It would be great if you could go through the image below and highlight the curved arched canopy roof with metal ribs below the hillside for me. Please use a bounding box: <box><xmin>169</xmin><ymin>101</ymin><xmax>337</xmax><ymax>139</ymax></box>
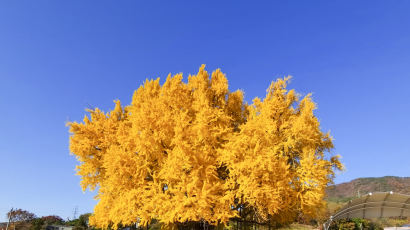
<box><xmin>325</xmin><ymin>192</ymin><xmax>410</xmax><ymax>229</ymax></box>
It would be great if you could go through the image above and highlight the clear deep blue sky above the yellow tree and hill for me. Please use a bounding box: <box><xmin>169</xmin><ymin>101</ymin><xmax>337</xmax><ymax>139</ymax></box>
<box><xmin>0</xmin><ymin>0</ymin><xmax>410</xmax><ymax>221</ymax></box>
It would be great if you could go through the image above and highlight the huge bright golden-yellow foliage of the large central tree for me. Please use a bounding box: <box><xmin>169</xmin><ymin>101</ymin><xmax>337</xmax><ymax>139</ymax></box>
<box><xmin>69</xmin><ymin>66</ymin><xmax>342</xmax><ymax>228</ymax></box>
